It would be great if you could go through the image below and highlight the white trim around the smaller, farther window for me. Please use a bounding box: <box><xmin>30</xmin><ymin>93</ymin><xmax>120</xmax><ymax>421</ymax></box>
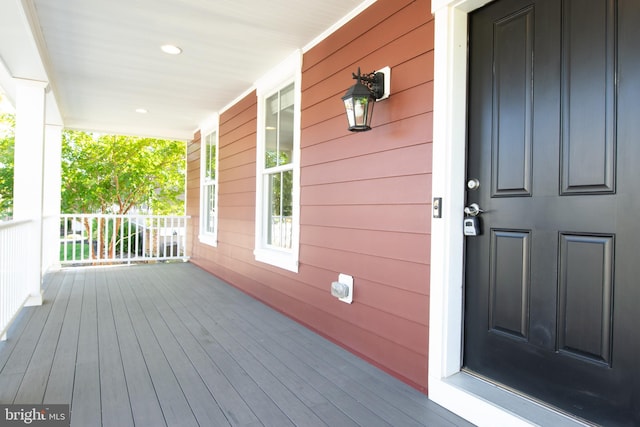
<box><xmin>198</xmin><ymin>114</ymin><xmax>220</xmax><ymax>246</ymax></box>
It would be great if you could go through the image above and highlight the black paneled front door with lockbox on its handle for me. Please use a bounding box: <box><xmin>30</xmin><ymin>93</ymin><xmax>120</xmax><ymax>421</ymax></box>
<box><xmin>461</xmin><ymin>0</ymin><xmax>640</xmax><ymax>426</ymax></box>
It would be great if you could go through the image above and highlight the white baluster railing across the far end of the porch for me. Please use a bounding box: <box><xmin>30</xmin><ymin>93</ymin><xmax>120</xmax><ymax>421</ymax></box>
<box><xmin>60</xmin><ymin>214</ymin><xmax>189</xmax><ymax>265</ymax></box>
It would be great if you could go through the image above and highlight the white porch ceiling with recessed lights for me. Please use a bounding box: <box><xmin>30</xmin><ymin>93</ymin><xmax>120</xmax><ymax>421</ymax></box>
<box><xmin>0</xmin><ymin>0</ymin><xmax>375</xmax><ymax>140</ymax></box>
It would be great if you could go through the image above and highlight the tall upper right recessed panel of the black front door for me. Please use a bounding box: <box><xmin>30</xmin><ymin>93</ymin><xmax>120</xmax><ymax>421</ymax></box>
<box><xmin>562</xmin><ymin>0</ymin><xmax>616</xmax><ymax>194</ymax></box>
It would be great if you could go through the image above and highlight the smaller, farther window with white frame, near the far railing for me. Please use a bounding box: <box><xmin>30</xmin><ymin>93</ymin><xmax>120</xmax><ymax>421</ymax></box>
<box><xmin>199</xmin><ymin>122</ymin><xmax>218</xmax><ymax>246</ymax></box>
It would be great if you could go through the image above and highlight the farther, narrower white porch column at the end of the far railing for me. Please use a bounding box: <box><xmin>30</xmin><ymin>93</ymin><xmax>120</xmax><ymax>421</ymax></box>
<box><xmin>42</xmin><ymin>124</ymin><xmax>62</xmax><ymax>274</ymax></box>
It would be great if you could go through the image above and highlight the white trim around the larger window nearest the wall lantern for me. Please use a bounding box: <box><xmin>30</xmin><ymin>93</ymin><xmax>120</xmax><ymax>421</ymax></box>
<box><xmin>253</xmin><ymin>50</ymin><xmax>302</xmax><ymax>273</ymax></box>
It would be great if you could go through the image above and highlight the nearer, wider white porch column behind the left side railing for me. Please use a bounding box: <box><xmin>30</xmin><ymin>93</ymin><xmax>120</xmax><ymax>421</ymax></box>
<box><xmin>13</xmin><ymin>79</ymin><xmax>48</xmax><ymax>306</ymax></box>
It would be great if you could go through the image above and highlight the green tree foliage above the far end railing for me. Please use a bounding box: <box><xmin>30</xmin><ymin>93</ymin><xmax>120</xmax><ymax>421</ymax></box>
<box><xmin>62</xmin><ymin>131</ymin><xmax>186</xmax><ymax>215</ymax></box>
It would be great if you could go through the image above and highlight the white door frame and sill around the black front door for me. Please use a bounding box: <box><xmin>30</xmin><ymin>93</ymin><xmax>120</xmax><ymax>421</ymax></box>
<box><xmin>429</xmin><ymin>0</ymin><xmax>584</xmax><ymax>426</ymax></box>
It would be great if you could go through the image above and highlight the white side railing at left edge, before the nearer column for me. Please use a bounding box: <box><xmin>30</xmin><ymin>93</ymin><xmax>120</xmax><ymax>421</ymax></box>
<box><xmin>0</xmin><ymin>221</ymin><xmax>36</xmax><ymax>340</ymax></box>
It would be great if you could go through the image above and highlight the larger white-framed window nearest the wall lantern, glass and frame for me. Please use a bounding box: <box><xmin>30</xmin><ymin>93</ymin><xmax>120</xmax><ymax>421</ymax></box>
<box><xmin>255</xmin><ymin>51</ymin><xmax>300</xmax><ymax>272</ymax></box>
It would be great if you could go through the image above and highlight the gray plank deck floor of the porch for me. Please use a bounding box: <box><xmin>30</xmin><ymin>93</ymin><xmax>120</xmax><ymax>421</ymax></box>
<box><xmin>0</xmin><ymin>263</ymin><xmax>470</xmax><ymax>427</ymax></box>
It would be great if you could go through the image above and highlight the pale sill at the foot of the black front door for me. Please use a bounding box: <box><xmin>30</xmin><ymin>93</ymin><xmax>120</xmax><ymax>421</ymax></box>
<box><xmin>440</xmin><ymin>372</ymin><xmax>592</xmax><ymax>427</ymax></box>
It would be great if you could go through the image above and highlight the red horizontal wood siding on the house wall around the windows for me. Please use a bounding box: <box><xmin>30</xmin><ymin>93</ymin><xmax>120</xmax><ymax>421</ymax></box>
<box><xmin>187</xmin><ymin>0</ymin><xmax>433</xmax><ymax>391</ymax></box>
